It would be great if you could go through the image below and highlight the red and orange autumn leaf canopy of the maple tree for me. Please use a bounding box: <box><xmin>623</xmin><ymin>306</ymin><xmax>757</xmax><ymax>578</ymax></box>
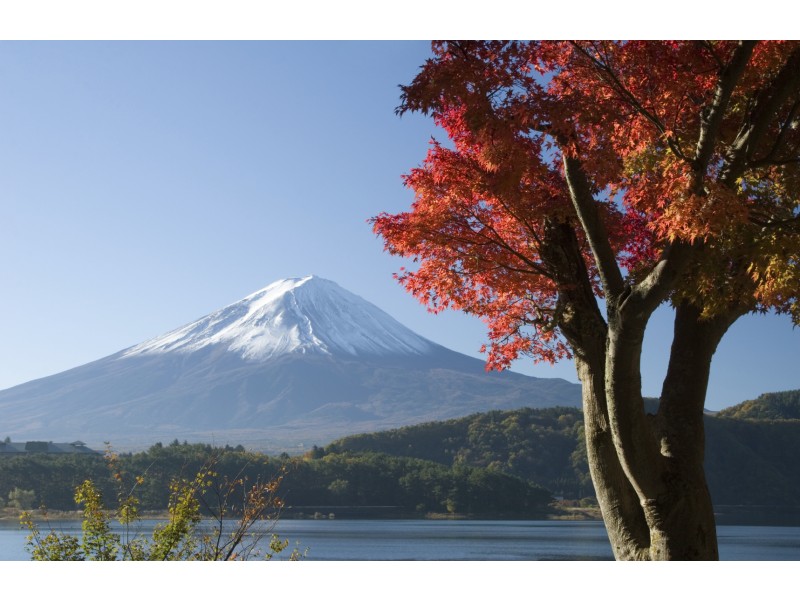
<box><xmin>373</xmin><ymin>41</ymin><xmax>800</xmax><ymax>368</ymax></box>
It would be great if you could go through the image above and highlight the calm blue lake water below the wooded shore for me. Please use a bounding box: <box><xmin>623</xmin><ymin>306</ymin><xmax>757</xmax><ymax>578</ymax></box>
<box><xmin>0</xmin><ymin>519</ymin><xmax>800</xmax><ymax>561</ymax></box>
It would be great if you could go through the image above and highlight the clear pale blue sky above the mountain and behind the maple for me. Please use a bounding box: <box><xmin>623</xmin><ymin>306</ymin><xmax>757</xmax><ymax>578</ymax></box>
<box><xmin>0</xmin><ymin>42</ymin><xmax>800</xmax><ymax>409</ymax></box>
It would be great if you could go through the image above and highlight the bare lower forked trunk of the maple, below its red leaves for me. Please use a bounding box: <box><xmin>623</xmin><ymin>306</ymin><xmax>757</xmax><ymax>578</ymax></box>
<box><xmin>576</xmin><ymin>305</ymin><xmax>738</xmax><ymax>560</ymax></box>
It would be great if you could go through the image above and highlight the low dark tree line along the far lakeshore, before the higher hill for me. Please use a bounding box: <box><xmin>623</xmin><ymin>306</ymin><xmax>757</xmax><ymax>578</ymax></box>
<box><xmin>0</xmin><ymin>442</ymin><xmax>552</xmax><ymax>517</ymax></box>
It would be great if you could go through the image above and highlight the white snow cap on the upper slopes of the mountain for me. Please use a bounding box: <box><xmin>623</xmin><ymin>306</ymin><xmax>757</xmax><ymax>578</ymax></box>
<box><xmin>123</xmin><ymin>275</ymin><xmax>435</xmax><ymax>361</ymax></box>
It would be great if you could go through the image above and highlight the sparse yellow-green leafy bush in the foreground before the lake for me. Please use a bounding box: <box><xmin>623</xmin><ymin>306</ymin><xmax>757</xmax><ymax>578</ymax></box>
<box><xmin>20</xmin><ymin>454</ymin><xmax>300</xmax><ymax>561</ymax></box>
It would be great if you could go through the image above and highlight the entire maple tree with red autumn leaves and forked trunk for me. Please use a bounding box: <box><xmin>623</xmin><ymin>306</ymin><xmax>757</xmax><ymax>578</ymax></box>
<box><xmin>372</xmin><ymin>41</ymin><xmax>800</xmax><ymax>559</ymax></box>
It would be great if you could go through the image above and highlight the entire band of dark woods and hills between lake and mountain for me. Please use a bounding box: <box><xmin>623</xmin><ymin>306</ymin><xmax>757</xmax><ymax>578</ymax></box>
<box><xmin>6</xmin><ymin>391</ymin><xmax>800</xmax><ymax>517</ymax></box>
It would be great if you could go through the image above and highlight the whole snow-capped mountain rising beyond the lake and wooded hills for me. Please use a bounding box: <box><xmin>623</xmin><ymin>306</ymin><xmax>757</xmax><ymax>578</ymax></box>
<box><xmin>0</xmin><ymin>276</ymin><xmax>580</xmax><ymax>452</ymax></box>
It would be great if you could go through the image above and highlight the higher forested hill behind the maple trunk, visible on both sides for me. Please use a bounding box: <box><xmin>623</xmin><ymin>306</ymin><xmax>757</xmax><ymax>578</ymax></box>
<box><xmin>323</xmin><ymin>391</ymin><xmax>800</xmax><ymax>507</ymax></box>
